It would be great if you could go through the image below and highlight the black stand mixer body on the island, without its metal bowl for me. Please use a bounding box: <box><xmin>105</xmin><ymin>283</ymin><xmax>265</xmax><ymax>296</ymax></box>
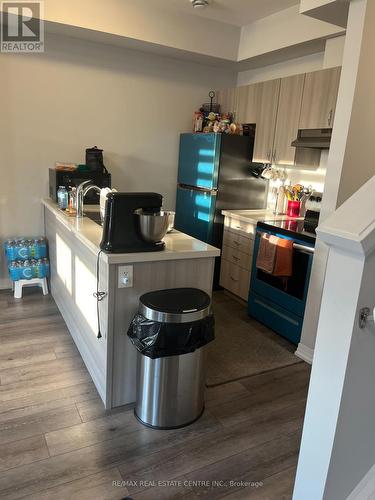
<box><xmin>100</xmin><ymin>192</ymin><xmax>165</xmax><ymax>253</ymax></box>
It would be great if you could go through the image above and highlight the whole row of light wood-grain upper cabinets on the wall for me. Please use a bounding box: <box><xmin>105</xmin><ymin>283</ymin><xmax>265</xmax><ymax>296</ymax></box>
<box><xmin>217</xmin><ymin>67</ymin><xmax>341</xmax><ymax>166</ymax></box>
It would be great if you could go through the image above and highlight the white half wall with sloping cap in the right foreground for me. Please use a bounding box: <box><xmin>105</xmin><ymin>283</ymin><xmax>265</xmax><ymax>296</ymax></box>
<box><xmin>293</xmin><ymin>175</ymin><xmax>375</xmax><ymax>500</ymax></box>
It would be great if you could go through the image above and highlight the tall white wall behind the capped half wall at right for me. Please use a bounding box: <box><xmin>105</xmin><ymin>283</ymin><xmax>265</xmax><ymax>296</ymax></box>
<box><xmin>297</xmin><ymin>0</ymin><xmax>375</xmax><ymax>354</ymax></box>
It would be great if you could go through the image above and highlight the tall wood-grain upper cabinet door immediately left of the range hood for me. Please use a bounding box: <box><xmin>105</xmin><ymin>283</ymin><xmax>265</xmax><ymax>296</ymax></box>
<box><xmin>272</xmin><ymin>74</ymin><xmax>305</xmax><ymax>165</ymax></box>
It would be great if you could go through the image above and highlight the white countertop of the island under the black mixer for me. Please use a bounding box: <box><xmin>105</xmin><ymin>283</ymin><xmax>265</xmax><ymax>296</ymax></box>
<box><xmin>42</xmin><ymin>199</ymin><xmax>220</xmax><ymax>264</ymax></box>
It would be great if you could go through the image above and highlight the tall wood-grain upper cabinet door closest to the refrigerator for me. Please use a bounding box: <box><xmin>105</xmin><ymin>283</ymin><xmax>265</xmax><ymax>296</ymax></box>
<box><xmin>253</xmin><ymin>79</ymin><xmax>280</xmax><ymax>163</ymax></box>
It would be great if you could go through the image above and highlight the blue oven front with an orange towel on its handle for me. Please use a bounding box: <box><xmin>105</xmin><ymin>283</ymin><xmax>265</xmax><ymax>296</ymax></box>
<box><xmin>248</xmin><ymin>226</ymin><xmax>315</xmax><ymax>344</ymax></box>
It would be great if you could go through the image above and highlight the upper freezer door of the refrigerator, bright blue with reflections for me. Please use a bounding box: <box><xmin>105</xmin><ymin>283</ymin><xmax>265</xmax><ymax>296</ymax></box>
<box><xmin>178</xmin><ymin>134</ymin><xmax>221</xmax><ymax>190</ymax></box>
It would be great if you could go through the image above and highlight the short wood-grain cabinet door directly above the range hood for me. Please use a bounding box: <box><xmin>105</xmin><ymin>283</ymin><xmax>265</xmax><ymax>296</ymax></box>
<box><xmin>299</xmin><ymin>67</ymin><xmax>341</xmax><ymax>128</ymax></box>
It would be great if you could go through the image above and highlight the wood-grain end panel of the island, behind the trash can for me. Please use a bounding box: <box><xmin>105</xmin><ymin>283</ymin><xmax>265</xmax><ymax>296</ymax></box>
<box><xmin>111</xmin><ymin>257</ymin><xmax>215</xmax><ymax>407</ymax></box>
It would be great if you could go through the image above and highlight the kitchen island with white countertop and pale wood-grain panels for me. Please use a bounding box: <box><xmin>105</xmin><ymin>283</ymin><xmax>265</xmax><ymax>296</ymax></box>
<box><xmin>43</xmin><ymin>199</ymin><xmax>220</xmax><ymax>408</ymax></box>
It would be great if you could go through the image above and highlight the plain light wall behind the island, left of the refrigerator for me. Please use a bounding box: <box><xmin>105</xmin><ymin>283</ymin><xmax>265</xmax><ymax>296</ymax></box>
<box><xmin>0</xmin><ymin>35</ymin><xmax>237</xmax><ymax>286</ymax></box>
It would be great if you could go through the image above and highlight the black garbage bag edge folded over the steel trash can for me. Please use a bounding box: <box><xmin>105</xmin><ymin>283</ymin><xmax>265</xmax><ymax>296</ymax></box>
<box><xmin>128</xmin><ymin>314</ymin><xmax>215</xmax><ymax>359</ymax></box>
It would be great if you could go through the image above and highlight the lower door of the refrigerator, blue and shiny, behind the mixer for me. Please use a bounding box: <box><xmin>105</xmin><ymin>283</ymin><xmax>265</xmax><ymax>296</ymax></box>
<box><xmin>175</xmin><ymin>187</ymin><xmax>216</xmax><ymax>243</ymax></box>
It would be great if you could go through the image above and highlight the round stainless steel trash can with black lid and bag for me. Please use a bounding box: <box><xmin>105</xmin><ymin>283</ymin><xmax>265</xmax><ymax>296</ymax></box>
<box><xmin>129</xmin><ymin>288</ymin><xmax>214</xmax><ymax>429</ymax></box>
